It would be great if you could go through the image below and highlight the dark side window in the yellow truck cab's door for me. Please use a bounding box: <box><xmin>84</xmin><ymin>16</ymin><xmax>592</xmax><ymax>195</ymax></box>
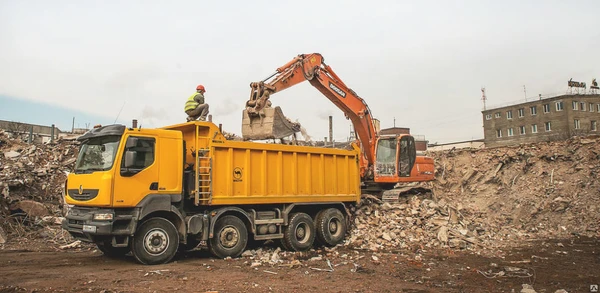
<box><xmin>121</xmin><ymin>137</ymin><xmax>156</xmax><ymax>176</ymax></box>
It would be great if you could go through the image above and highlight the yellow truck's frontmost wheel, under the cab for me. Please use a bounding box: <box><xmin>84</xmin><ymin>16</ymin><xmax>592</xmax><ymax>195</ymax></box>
<box><xmin>131</xmin><ymin>218</ymin><xmax>179</xmax><ymax>265</ymax></box>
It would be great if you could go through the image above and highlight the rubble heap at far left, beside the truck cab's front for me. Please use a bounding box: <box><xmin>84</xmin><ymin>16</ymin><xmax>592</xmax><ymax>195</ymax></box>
<box><xmin>0</xmin><ymin>129</ymin><xmax>78</xmax><ymax>240</ymax></box>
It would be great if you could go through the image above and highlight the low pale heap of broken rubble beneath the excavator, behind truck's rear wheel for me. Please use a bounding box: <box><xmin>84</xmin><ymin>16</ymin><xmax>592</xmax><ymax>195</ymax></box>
<box><xmin>346</xmin><ymin>194</ymin><xmax>494</xmax><ymax>252</ymax></box>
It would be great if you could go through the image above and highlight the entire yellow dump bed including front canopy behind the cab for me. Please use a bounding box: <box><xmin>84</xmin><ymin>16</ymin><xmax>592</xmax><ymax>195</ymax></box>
<box><xmin>165</xmin><ymin>122</ymin><xmax>360</xmax><ymax>205</ymax></box>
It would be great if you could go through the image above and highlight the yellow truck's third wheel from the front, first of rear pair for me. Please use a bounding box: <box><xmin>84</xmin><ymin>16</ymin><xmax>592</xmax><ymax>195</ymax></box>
<box><xmin>282</xmin><ymin>213</ymin><xmax>315</xmax><ymax>251</ymax></box>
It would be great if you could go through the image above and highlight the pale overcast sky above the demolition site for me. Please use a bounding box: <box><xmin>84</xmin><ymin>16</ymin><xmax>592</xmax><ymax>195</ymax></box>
<box><xmin>0</xmin><ymin>0</ymin><xmax>600</xmax><ymax>143</ymax></box>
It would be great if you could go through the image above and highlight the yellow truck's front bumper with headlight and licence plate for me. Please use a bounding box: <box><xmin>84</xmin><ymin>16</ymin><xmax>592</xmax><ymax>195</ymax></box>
<box><xmin>62</xmin><ymin>207</ymin><xmax>139</xmax><ymax>242</ymax></box>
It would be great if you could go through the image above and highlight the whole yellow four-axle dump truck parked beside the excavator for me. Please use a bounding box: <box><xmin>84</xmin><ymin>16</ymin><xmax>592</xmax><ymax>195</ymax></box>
<box><xmin>62</xmin><ymin>121</ymin><xmax>360</xmax><ymax>264</ymax></box>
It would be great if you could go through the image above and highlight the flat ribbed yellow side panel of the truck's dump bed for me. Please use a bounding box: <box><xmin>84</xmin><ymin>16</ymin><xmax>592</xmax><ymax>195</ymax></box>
<box><xmin>210</xmin><ymin>141</ymin><xmax>360</xmax><ymax>205</ymax></box>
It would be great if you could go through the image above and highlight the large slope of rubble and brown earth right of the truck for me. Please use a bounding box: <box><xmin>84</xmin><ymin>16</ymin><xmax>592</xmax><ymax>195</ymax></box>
<box><xmin>347</xmin><ymin>137</ymin><xmax>600</xmax><ymax>252</ymax></box>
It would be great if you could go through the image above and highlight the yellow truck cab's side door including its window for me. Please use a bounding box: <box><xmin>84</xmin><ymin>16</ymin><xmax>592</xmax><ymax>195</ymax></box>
<box><xmin>113</xmin><ymin>135</ymin><xmax>159</xmax><ymax>207</ymax></box>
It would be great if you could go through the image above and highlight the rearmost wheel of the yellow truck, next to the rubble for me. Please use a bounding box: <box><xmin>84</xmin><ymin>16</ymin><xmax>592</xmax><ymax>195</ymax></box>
<box><xmin>315</xmin><ymin>208</ymin><xmax>346</xmax><ymax>246</ymax></box>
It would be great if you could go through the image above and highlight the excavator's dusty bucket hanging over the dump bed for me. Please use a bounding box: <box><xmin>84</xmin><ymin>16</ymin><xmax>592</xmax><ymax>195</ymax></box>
<box><xmin>242</xmin><ymin>107</ymin><xmax>300</xmax><ymax>140</ymax></box>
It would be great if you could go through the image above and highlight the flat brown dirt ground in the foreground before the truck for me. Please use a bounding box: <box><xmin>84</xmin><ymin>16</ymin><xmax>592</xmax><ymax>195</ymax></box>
<box><xmin>0</xmin><ymin>238</ymin><xmax>600</xmax><ymax>293</ymax></box>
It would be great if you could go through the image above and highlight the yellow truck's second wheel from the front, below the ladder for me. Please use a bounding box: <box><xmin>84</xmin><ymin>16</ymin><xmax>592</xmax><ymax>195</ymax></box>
<box><xmin>209</xmin><ymin>215</ymin><xmax>248</xmax><ymax>258</ymax></box>
